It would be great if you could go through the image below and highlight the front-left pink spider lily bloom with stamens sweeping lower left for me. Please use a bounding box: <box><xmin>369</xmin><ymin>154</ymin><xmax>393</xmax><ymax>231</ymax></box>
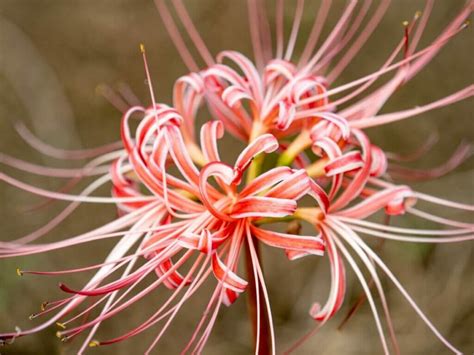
<box><xmin>2</xmin><ymin>105</ymin><xmax>327</xmax><ymax>349</ymax></box>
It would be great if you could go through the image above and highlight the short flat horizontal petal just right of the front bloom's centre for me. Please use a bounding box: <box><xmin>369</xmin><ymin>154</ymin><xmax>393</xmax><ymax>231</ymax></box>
<box><xmin>230</xmin><ymin>196</ymin><xmax>297</xmax><ymax>218</ymax></box>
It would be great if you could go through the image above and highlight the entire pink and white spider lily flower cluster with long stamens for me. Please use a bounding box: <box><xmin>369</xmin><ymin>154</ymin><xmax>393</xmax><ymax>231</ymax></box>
<box><xmin>0</xmin><ymin>0</ymin><xmax>474</xmax><ymax>353</ymax></box>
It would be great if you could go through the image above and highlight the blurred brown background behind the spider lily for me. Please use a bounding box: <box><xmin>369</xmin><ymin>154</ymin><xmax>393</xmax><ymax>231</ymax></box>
<box><xmin>0</xmin><ymin>0</ymin><xmax>474</xmax><ymax>354</ymax></box>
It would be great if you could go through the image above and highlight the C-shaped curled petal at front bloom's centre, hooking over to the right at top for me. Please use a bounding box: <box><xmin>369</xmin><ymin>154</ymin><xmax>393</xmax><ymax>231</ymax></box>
<box><xmin>199</xmin><ymin>162</ymin><xmax>234</xmax><ymax>222</ymax></box>
